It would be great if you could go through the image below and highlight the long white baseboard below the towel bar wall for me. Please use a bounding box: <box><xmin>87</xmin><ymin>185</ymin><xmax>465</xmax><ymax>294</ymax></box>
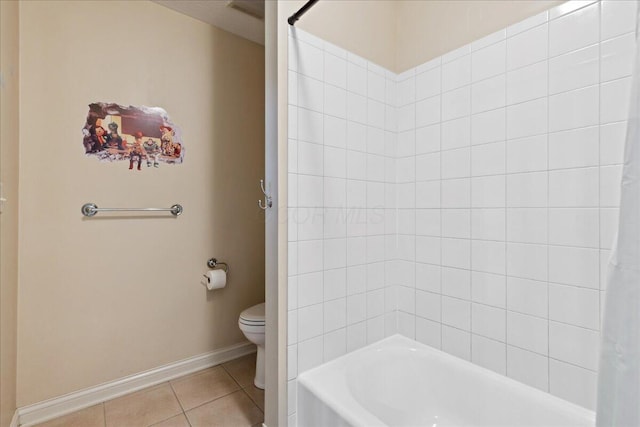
<box><xmin>16</xmin><ymin>341</ymin><xmax>256</xmax><ymax>427</ymax></box>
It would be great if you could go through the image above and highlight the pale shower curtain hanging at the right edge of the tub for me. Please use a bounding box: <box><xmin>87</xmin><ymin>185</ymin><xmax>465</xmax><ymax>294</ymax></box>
<box><xmin>596</xmin><ymin>4</ymin><xmax>640</xmax><ymax>427</ymax></box>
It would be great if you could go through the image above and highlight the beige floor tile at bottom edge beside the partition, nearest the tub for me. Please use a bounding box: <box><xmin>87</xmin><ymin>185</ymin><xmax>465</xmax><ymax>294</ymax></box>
<box><xmin>187</xmin><ymin>391</ymin><xmax>264</xmax><ymax>427</ymax></box>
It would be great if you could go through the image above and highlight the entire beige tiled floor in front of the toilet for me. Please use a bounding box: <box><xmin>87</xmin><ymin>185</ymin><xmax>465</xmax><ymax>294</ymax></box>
<box><xmin>31</xmin><ymin>353</ymin><xmax>264</xmax><ymax>427</ymax></box>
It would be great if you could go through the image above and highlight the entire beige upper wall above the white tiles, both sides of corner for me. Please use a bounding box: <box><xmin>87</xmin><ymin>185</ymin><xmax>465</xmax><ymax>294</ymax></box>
<box><xmin>282</xmin><ymin>0</ymin><xmax>563</xmax><ymax>73</ymax></box>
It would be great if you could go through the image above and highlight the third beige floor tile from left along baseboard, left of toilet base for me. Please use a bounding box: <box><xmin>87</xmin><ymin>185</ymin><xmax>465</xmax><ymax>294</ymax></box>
<box><xmin>171</xmin><ymin>366</ymin><xmax>239</xmax><ymax>411</ymax></box>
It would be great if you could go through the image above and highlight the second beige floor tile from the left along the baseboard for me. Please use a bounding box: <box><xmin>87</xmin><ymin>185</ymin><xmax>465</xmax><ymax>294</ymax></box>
<box><xmin>104</xmin><ymin>383</ymin><xmax>182</xmax><ymax>427</ymax></box>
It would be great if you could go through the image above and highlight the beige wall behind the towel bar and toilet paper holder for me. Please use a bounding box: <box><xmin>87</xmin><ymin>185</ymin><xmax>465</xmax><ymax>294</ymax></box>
<box><xmin>18</xmin><ymin>1</ymin><xmax>264</xmax><ymax>406</ymax></box>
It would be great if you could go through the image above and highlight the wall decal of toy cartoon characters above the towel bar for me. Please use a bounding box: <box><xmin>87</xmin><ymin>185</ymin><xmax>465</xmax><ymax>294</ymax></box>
<box><xmin>82</xmin><ymin>102</ymin><xmax>185</xmax><ymax>170</ymax></box>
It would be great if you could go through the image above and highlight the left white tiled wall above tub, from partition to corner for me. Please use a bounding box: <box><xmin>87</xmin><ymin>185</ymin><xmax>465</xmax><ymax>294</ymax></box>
<box><xmin>287</xmin><ymin>30</ymin><xmax>398</xmax><ymax>422</ymax></box>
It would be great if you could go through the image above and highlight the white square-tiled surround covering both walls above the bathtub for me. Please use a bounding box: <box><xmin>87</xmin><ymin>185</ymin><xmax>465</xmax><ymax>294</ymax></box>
<box><xmin>288</xmin><ymin>0</ymin><xmax>635</xmax><ymax>425</ymax></box>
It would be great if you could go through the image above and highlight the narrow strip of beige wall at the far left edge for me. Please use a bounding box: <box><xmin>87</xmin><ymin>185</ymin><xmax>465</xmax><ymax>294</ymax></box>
<box><xmin>0</xmin><ymin>1</ymin><xmax>19</xmax><ymax>427</ymax></box>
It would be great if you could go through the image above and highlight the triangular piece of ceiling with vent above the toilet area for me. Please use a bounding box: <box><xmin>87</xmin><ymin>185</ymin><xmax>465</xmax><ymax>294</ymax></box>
<box><xmin>153</xmin><ymin>0</ymin><xmax>264</xmax><ymax>45</ymax></box>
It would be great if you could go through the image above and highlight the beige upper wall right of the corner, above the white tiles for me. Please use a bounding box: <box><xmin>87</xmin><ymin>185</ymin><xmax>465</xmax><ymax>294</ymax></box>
<box><xmin>395</xmin><ymin>0</ymin><xmax>562</xmax><ymax>72</ymax></box>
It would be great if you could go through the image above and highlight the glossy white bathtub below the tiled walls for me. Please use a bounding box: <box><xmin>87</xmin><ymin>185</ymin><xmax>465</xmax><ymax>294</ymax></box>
<box><xmin>297</xmin><ymin>335</ymin><xmax>595</xmax><ymax>427</ymax></box>
